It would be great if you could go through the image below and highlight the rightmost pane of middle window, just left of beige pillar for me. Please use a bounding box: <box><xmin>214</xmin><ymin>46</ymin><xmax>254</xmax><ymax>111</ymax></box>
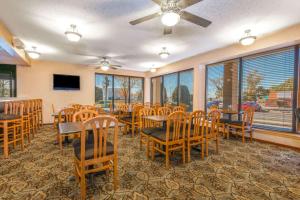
<box><xmin>178</xmin><ymin>70</ymin><xmax>194</xmax><ymax>112</ymax></box>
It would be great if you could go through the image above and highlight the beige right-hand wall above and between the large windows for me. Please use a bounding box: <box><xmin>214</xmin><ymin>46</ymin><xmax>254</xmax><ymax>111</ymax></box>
<box><xmin>146</xmin><ymin>24</ymin><xmax>300</xmax><ymax>110</ymax></box>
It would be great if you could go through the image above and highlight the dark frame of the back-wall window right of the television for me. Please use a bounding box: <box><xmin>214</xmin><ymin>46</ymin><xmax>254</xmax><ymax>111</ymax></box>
<box><xmin>95</xmin><ymin>72</ymin><xmax>145</xmax><ymax>109</ymax></box>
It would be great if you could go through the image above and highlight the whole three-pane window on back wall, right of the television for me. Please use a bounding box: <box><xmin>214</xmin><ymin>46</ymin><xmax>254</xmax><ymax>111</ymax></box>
<box><xmin>95</xmin><ymin>74</ymin><xmax>144</xmax><ymax>108</ymax></box>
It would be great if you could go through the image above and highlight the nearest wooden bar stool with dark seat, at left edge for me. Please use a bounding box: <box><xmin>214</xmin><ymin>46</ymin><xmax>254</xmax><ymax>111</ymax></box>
<box><xmin>0</xmin><ymin>102</ymin><xmax>24</xmax><ymax>158</ymax></box>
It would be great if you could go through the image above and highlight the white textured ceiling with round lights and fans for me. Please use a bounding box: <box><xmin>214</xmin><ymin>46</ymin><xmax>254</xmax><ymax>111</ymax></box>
<box><xmin>0</xmin><ymin>0</ymin><xmax>300</xmax><ymax>71</ymax></box>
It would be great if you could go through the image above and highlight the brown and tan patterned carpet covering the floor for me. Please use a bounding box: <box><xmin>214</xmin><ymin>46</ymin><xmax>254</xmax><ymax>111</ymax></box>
<box><xmin>0</xmin><ymin>126</ymin><xmax>300</xmax><ymax>200</ymax></box>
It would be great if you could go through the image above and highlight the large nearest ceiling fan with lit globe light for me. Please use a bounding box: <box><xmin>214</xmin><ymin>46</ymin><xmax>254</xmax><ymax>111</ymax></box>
<box><xmin>129</xmin><ymin>0</ymin><xmax>212</xmax><ymax>35</ymax></box>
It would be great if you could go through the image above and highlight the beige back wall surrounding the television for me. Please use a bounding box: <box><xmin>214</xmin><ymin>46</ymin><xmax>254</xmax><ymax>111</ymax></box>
<box><xmin>17</xmin><ymin>61</ymin><xmax>145</xmax><ymax>123</ymax></box>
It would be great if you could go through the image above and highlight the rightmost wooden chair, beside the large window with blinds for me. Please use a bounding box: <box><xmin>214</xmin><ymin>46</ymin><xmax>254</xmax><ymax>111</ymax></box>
<box><xmin>227</xmin><ymin>107</ymin><xmax>255</xmax><ymax>143</ymax></box>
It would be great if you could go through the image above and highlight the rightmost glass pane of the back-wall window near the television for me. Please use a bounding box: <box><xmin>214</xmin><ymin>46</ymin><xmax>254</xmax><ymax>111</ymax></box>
<box><xmin>130</xmin><ymin>77</ymin><xmax>144</xmax><ymax>103</ymax></box>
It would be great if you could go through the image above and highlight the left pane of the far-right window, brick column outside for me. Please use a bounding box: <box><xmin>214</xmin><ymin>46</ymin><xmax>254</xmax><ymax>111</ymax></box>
<box><xmin>206</xmin><ymin>60</ymin><xmax>239</xmax><ymax>110</ymax></box>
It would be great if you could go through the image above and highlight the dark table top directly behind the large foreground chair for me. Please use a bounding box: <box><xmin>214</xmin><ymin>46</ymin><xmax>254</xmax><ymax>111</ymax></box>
<box><xmin>58</xmin><ymin>122</ymin><xmax>124</xmax><ymax>134</ymax></box>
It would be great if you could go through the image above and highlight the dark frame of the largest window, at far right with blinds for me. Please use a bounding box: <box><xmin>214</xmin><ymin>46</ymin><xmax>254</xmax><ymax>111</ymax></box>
<box><xmin>204</xmin><ymin>44</ymin><xmax>300</xmax><ymax>133</ymax></box>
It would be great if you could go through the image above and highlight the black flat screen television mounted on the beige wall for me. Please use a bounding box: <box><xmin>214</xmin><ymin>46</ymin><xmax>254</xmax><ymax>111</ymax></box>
<box><xmin>53</xmin><ymin>74</ymin><xmax>80</xmax><ymax>90</ymax></box>
